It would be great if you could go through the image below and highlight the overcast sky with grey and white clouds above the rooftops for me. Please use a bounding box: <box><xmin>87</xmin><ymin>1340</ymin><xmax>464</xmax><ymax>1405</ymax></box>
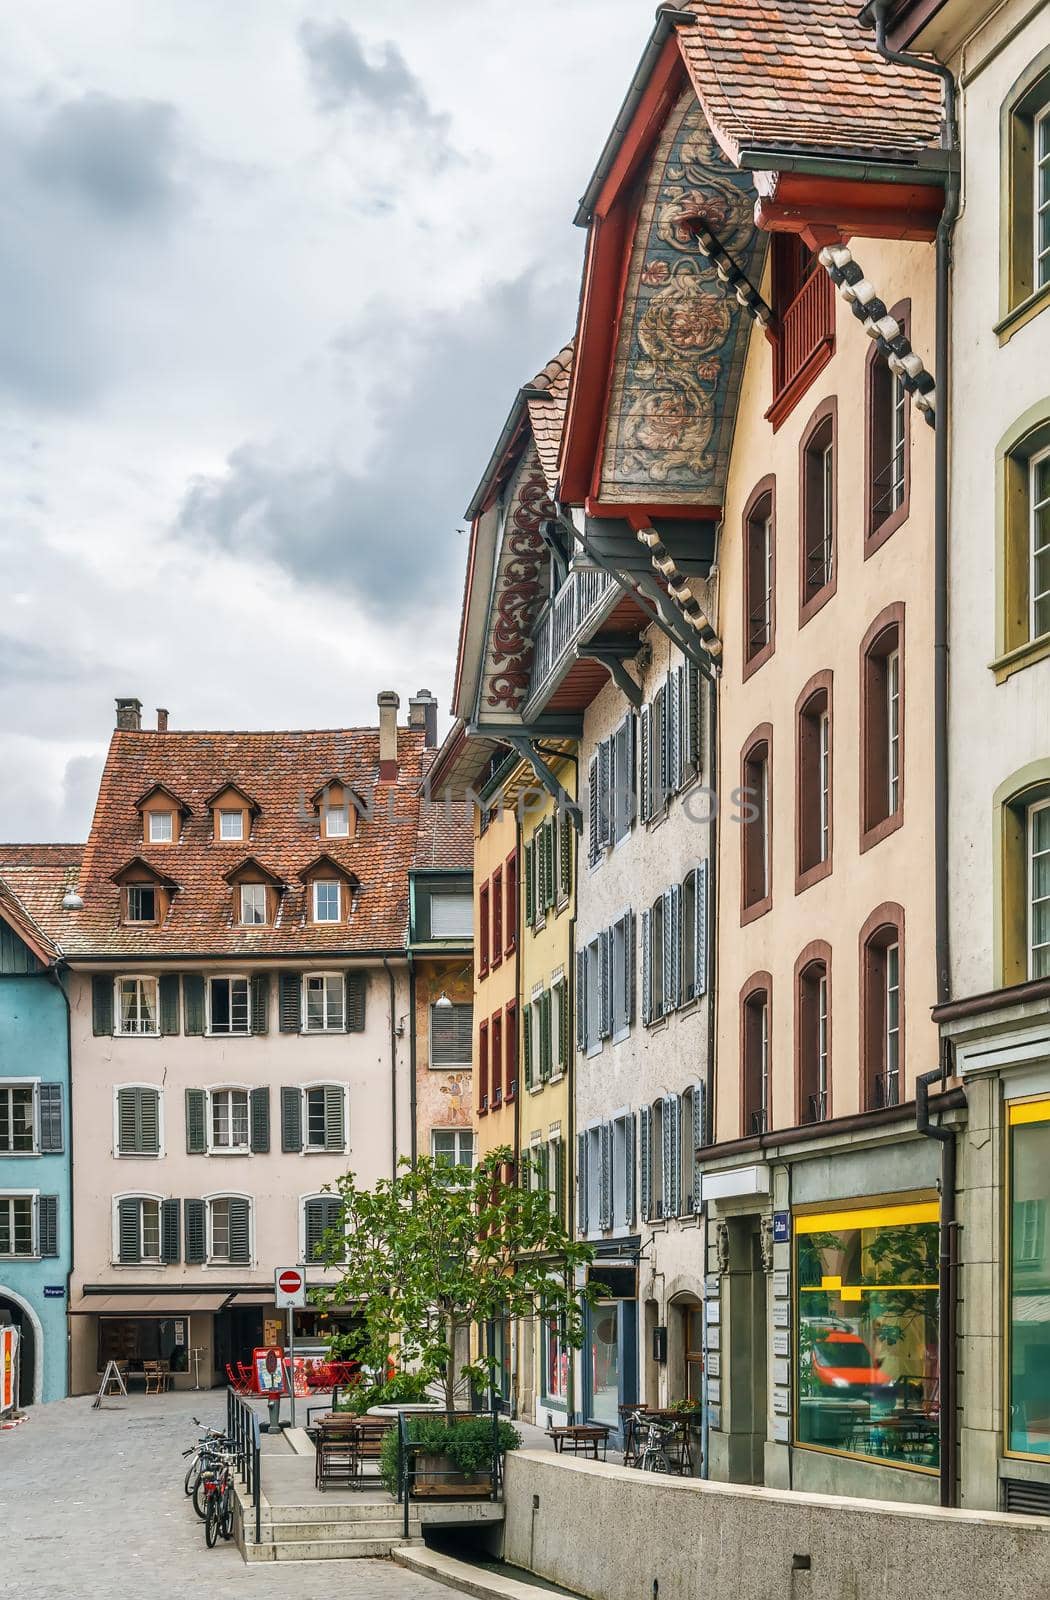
<box><xmin>0</xmin><ymin>0</ymin><xmax>653</xmax><ymax>840</ymax></box>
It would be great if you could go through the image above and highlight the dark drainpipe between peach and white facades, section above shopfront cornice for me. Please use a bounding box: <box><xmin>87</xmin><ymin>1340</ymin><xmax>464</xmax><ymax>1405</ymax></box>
<box><xmin>871</xmin><ymin>0</ymin><xmax>959</xmax><ymax>1005</ymax></box>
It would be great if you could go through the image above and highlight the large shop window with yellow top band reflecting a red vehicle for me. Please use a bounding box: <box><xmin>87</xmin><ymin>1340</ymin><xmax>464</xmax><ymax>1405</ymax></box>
<box><xmin>794</xmin><ymin>1203</ymin><xmax>940</xmax><ymax>1470</ymax></box>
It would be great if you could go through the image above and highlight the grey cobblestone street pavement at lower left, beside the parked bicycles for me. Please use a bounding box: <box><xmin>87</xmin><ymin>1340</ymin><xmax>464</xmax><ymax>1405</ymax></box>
<box><xmin>0</xmin><ymin>1390</ymin><xmax>448</xmax><ymax>1600</ymax></box>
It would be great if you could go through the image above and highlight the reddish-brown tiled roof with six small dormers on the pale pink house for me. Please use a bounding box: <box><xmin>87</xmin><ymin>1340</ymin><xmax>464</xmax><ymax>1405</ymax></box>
<box><xmin>27</xmin><ymin>728</ymin><xmax>464</xmax><ymax>960</ymax></box>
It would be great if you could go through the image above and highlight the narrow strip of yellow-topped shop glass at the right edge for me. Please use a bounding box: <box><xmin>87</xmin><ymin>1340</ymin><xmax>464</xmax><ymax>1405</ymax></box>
<box><xmin>1007</xmin><ymin>1101</ymin><xmax>1050</xmax><ymax>1456</ymax></box>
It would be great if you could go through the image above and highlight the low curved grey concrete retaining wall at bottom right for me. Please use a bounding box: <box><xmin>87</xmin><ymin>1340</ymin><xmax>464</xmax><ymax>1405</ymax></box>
<box><xmin>504</xmin><ymin>1450</ymin><xmax>1050</xmax><ymax>1600</ymax></box>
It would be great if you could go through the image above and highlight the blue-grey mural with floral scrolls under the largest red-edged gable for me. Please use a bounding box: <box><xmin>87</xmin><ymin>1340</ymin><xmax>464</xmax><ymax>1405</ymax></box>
<box><xmin>600</xmin><ymin>90</ymin><xmax>765</xmax><ymax>504</ymax></box>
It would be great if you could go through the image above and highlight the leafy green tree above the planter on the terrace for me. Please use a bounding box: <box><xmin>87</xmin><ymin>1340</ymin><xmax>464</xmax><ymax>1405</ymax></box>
<box><xmin>314</xmin><ymin>1147</ymin><xmax>594</xmax><ymax>1410</ymax></box>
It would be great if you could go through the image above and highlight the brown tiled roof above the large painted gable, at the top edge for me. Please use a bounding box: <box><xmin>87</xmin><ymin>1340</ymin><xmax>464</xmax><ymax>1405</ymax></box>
<box><xmin>679</xmin><ymin>0</ymin><xmax>941</xmax><ymax>160</ymax></box>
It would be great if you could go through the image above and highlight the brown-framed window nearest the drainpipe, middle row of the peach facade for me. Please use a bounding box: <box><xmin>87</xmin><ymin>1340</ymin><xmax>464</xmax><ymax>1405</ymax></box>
<box><xmin>861</xmin><ymin>605</ymin><xmax>904</xmax><ymax>851</ymax></box>
